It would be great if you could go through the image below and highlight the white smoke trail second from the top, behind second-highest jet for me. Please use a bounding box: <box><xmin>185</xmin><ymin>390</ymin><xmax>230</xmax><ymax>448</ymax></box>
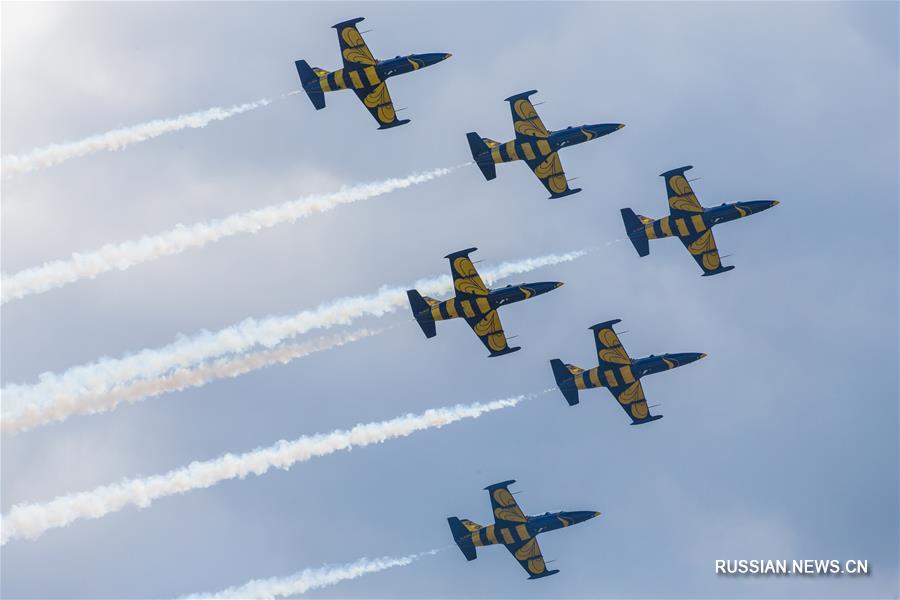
<box><xmin>0</xmin><ymin>165</ymin><xmax>461</xmax><ymax>302</ymax></box>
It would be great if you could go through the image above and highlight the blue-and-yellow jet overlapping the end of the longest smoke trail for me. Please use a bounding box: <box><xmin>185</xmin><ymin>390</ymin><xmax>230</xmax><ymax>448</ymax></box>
<box><xmin>406</xmin><ymin>248</ymin><xmax>562</xmax><ymax>356</ymax></box>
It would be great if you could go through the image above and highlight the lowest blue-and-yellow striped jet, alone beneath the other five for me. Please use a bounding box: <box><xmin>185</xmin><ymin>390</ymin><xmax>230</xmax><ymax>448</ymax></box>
<box><xmin>447</xmin><ymin>479</ymin><xmax>600</xmax><ymax>579</ymax></box>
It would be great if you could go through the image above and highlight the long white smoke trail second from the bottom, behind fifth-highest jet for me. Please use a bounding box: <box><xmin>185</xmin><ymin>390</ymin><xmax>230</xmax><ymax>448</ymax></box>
<box><xmin>0</xmin><ymin>394</ymin><xmax>535</xmax><ymax>545</ymax></box>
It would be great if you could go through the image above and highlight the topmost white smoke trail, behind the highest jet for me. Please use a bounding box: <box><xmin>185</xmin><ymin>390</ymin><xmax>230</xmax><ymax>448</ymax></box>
<box><xmin>2</xmin><ymin>98</ymin><xmax>272</xmax><ymax>177</ymax></box>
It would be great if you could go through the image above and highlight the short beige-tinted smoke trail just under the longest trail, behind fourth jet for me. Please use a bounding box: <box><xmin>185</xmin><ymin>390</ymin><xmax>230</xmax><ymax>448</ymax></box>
<box><xmin>0</xmin><ymin>329</ymin><xmax>384</xmax><ymax>433</ymax></box>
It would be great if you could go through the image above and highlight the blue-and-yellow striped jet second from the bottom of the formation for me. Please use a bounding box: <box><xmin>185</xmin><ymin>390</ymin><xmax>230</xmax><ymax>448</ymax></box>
<box><xmin>550</xmin><ymin>319</ymin><xmax>706</xmax><ymax>425</ymax></box>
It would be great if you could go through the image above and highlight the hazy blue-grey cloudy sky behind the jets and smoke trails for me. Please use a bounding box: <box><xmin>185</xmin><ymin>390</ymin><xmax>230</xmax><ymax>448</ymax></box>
<box><xmin>0</xmin><ymin>2</ymin><xmax>900</xmax><ymax>598</ymax></box>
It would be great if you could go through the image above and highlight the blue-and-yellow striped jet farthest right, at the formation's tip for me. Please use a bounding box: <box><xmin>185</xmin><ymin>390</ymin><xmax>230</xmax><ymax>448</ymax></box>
<box><xmin>622</xmin><ymin>165</ymin><xmax>778</xmax><ymax>277</ymax></box>
